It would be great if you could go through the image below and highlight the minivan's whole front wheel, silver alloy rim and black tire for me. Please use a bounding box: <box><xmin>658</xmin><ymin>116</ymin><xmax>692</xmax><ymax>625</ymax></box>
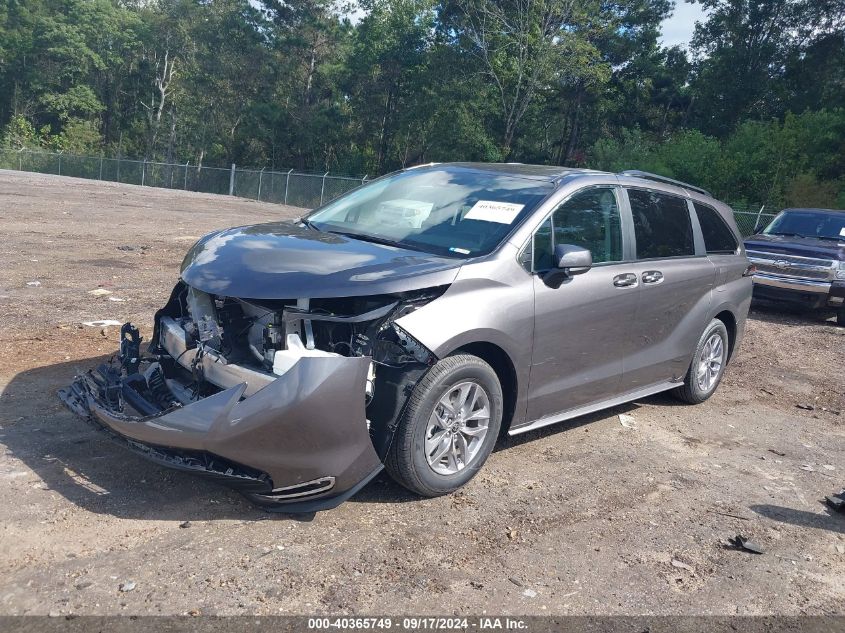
<box><xmin>384</xmin><ymin>354</ymin><xmax>502</xmax><ymax>497</ymax></box>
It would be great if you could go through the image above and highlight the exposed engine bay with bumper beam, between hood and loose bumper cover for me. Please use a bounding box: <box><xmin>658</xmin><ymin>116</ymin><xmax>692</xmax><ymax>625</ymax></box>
<box><xmin>146</xmin><ymin>283</ymin><xmax>445</xmax><ymax>405</ymax></box>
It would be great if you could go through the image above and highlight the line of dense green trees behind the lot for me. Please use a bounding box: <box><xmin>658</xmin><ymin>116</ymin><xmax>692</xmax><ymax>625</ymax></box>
<box><xmin>0</xmin><ymin>0</ymin><xmax>845</xmax><ymax>207</ymax></box>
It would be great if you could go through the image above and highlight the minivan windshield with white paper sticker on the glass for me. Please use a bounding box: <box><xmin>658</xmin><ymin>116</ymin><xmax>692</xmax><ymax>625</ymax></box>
<box><xmin>306</xmin><ymin>166</ymin><xmax>554</xmax><ymax>257</ymax></box>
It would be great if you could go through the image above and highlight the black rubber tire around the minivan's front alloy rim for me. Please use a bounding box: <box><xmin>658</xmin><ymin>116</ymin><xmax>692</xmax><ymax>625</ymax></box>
<box><xmin>384</xmin><ymin>354</ymin><xmax>502</xmax><ymax>497</ymax></box>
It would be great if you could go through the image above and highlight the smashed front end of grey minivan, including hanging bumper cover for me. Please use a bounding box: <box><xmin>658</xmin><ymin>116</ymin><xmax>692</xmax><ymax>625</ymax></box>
<box><xmin>60</xmin><ymin>282</ymin><xmax>445</xmax><ymax>512</ymax></box>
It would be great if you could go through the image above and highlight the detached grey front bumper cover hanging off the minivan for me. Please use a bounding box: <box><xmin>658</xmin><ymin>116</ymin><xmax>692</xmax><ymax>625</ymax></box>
<box><xmin>60</xmin><ymin>334</ymin><xmax>383</xmax><ymax>512</ymax></box>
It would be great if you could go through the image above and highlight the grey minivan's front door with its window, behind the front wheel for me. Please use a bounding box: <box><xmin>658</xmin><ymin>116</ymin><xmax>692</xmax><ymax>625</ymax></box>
<box><xmin>523</xmin><ymin>186</ymin><xmax>638</xmax><ymax>420</ymax></box>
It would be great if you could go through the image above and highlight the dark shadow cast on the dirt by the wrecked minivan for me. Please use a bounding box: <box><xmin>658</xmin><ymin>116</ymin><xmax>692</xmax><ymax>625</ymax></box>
<box><xmin>0</xmin><ymin>356</ymin><xmax>677</xmax><ymax>521</ymax></box>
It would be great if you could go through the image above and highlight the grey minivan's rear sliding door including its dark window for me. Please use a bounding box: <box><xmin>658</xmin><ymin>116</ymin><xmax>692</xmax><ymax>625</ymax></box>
<box><xmin>623</xmin><ymin>187</ymin><xmax>716</xmax><ymax>392</ymax></box>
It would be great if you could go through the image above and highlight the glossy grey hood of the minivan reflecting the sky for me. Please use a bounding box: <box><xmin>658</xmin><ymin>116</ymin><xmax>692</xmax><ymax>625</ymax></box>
<box><xmin>181</xmin><ymin>222</ymin><xmax>462</xmax><ymax>299</ymax></box>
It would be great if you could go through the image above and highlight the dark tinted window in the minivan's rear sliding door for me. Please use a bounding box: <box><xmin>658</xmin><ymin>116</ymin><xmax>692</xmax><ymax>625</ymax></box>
<box><xmin>628</xmin><ymin>189</ymin><xmax>695</xmax><ymax>259</ymax></box>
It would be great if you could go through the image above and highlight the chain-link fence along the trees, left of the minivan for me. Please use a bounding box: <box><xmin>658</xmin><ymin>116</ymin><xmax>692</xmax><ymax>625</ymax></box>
<box><xmin>0</xmin><ymin>150</ymin><xmax>367</xmax><ymax>209</ymax></box>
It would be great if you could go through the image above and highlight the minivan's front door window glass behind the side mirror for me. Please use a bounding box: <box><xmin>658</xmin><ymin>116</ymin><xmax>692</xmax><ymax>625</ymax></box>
<box><xmin>533</xmin><ymin>187</ymin><xmax>622</xmax><ymax>270</ymax></box>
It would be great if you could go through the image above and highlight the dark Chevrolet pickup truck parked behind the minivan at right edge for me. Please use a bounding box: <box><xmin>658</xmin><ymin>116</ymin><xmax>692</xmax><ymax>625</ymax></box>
<box><xmin>745</xmin><ymin>209</ymin><xmax>845</xmax><ymax>325</ymax></box>
